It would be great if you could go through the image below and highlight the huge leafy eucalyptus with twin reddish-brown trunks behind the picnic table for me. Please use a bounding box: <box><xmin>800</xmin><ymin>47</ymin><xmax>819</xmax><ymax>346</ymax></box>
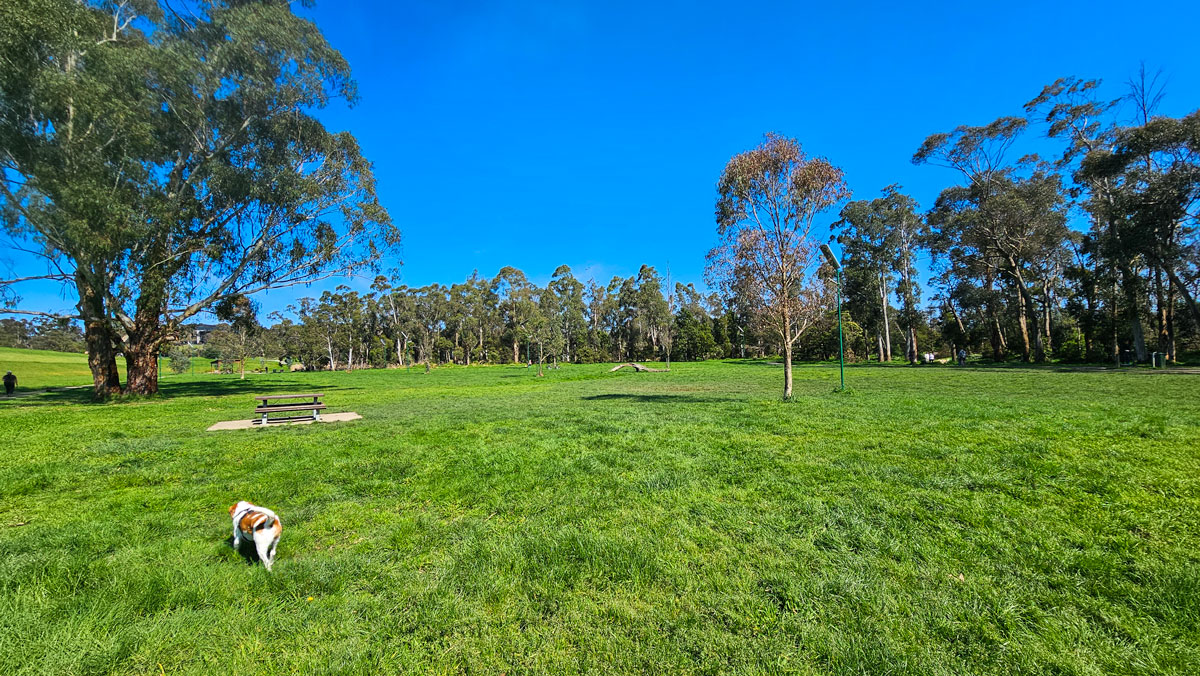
<box><xmin>0</xmin><ymin>0</ymin><xmax>398</xmax><ymax>394</ymax></box>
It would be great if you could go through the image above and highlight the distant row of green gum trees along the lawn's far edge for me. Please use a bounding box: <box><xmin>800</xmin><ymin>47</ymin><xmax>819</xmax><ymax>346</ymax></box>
<box><xmin>187</xmin><ymin>265</ymin><xmax>892</xmax><ymax>369</ymax></box>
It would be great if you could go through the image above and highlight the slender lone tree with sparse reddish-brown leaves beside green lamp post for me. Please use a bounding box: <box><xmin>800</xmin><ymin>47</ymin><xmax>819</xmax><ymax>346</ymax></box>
<box><xmin>708</xmin><ymin>133</ymin><xmax>850</xmax><ymax>399</ymax></box>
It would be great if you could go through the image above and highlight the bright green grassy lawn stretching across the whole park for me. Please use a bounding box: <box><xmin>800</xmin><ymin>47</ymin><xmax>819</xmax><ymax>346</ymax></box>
<box><xmin>0</xmin><ymin>363</ymin><xmax>1200</xmax><ymax>675</ymax></box>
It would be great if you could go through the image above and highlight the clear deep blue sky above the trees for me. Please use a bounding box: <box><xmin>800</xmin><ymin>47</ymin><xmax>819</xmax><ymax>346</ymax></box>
<box><xmin>9</xmin><ymin>0</ymin><xmax>1200</xmax><ymax>319</ymax></box>
